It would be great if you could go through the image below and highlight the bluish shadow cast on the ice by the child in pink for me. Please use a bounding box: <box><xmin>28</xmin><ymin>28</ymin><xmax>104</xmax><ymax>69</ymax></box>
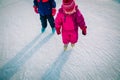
<box><xmin>40</xmin><ymin>50</ymin><xmax>72</xmax><ymax>80</ymax></box>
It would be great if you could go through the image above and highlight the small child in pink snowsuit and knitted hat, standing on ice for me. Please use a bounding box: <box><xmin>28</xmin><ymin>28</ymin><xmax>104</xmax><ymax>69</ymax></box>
<box><xmin>55</xmin><ymin>0</ymin><xmax>87</xmax><ymax>50</ymax></box>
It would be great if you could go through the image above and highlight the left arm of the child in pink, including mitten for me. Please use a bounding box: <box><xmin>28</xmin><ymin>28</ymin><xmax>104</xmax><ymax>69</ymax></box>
<box><xmin>55</xmin><ymin>13</ymin><xmax>62</xmax><ymax>35</ymax></box>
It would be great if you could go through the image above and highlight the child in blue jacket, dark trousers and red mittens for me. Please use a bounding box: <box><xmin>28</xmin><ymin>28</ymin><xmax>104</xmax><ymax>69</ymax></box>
<box><xmin>33</xmin><ymin>0</ymin><xmax>56</xmax><ymax>33</ymax></box>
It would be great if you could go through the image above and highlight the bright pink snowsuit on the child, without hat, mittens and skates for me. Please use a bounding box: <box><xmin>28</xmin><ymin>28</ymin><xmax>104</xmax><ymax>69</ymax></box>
<box><xmin>55</xmin><ymin>6</ymin><xmax>86</xmax><ymax>44</ymax></box>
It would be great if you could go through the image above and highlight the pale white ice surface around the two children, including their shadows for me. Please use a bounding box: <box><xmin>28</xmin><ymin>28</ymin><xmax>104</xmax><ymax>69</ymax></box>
<box><xmin>0</xmin><ymin>0</ymin><xmax>120</xmax><ymax>80</ymax></box>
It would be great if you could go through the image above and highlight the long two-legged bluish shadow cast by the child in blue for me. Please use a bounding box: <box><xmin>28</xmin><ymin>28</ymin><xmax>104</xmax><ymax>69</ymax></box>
<box><xmin>0</xmin><ymin>34</ymin><xmax>53</xmax><ymax>80</ymax></box>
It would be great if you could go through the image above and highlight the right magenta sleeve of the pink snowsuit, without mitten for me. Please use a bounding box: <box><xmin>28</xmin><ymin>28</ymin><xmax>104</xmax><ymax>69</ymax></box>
<box><xmin>77</xmin><ymin>10</ymin><xmax>86</xmax><ymax>30</ymax></box>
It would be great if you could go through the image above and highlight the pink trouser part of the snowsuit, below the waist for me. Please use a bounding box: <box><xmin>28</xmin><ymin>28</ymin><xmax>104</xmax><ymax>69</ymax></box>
<box><xmin>62</xmin><ymin>30</ymin><xmax>78</xmax><ymax>44</ymax></box>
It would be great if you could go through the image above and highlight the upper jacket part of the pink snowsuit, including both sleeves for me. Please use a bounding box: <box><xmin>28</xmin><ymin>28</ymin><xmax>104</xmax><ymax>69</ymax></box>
<box><xmin>55</xmin><ymin>6</ymin><xmax>86</xmax><ymax>31</ymax></box>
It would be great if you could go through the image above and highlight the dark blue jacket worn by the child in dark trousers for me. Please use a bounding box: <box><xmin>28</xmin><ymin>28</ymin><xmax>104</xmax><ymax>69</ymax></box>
<box><xmin>33</xmin><ymin>0</ymin><xmax>56</xmax><ymax>16</ymax></box>
